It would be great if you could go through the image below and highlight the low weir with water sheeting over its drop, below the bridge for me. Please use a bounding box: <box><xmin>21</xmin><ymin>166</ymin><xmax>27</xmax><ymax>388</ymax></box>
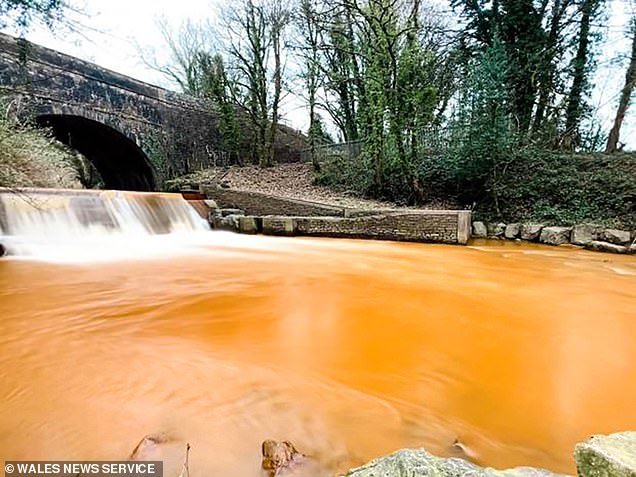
<box><xmin>0</xmin><ymin>189</ymin><xmax>210</xmax><ymax>256</ymax></box>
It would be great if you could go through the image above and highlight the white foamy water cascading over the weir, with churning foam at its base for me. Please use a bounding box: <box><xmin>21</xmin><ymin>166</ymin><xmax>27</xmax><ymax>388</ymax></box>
<box><xmin>0</xmin><ymin>190</ymin><xmax>216</xmax><ymax>262</ymax></box>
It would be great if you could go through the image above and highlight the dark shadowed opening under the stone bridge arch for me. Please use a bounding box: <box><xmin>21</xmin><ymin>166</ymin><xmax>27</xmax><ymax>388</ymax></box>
<box><xmin>37</xmin><ymin>115</ymin><xmax>156</xmax><ymax>191</ymax></box>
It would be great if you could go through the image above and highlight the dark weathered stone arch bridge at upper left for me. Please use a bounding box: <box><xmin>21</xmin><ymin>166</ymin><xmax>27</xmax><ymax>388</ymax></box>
<box><xmin>0</xmin><ymin>34</ymin><xmax>304</xmax><ymax>190</ymax></box>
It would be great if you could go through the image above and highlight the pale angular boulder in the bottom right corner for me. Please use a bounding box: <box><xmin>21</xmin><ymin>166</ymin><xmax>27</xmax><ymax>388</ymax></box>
<box><xmin>574</xmin><ymin>432</ymin><xmax>636</xmax><ymax>477</ymax></box>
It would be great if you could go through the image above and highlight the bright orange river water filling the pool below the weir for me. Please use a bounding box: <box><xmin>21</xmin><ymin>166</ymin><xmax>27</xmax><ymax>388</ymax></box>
<box><xmin>0</xmin><ymin>237</ymin><xmax>636</xmax><ymax>477</ymax></box>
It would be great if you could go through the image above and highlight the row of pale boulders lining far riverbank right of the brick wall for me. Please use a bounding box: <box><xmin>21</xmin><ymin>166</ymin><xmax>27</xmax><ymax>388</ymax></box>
<box><xmin>472</xmin><ymin>221</ymin><xmax>636</xmax><ymax>254</ymax></box>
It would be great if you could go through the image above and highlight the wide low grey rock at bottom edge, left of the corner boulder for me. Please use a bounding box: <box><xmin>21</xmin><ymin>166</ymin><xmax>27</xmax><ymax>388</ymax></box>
<box><xmin>345</xmin><ymin>449</ymin><xmax>558</xmax><ymax>477</ymax></box>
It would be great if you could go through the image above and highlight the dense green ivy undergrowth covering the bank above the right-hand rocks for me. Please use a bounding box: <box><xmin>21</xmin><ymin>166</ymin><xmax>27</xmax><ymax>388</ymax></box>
<box><xmin>477</xmin><ymin>150</ymin><xmax>636</xmax><ymax>229</ymax></box>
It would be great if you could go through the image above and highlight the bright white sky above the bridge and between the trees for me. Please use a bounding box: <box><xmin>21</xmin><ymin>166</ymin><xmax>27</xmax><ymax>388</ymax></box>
<box><xmin>5</xmin><ymin>0</ymin><xmax>636</xmax><ymax>144</ymax></box>
